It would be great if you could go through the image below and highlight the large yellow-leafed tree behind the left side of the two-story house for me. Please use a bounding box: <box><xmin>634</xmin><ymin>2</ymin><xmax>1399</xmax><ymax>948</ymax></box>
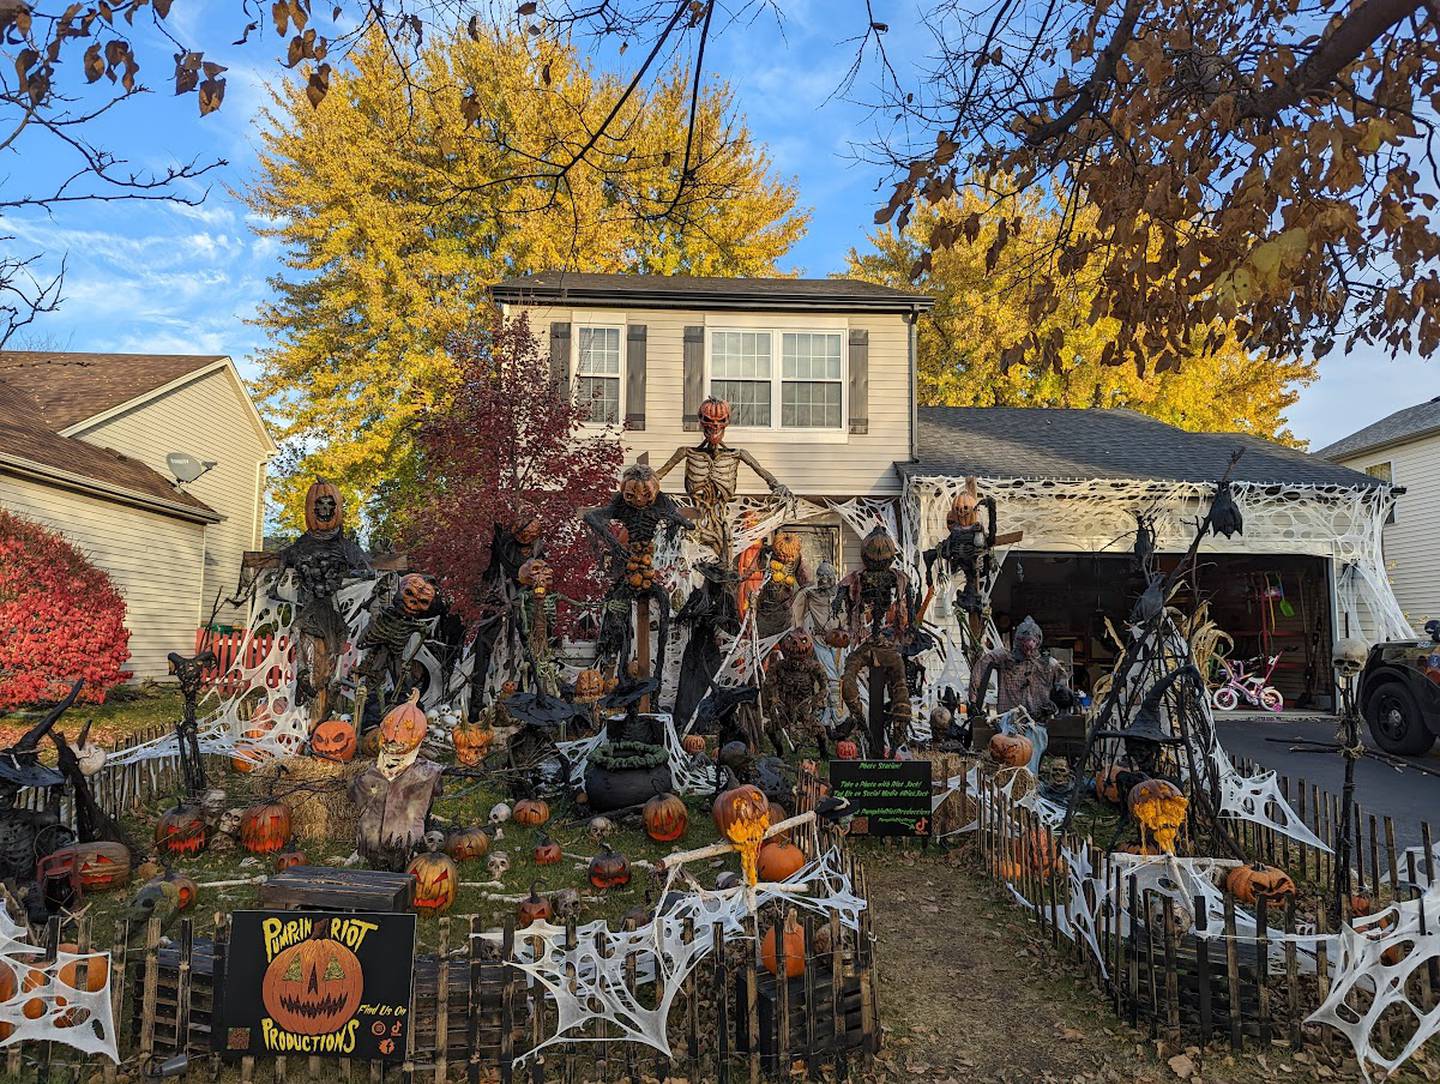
<box><xmin>245</xmin><ymin>30</ymin><xmax>806</xmax><ymax>536</ymax></box>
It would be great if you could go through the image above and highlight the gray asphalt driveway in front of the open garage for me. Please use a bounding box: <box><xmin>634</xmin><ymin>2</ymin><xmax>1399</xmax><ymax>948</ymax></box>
<box><xmin>1215</xmin><ymin>713</ymin><xmax>1440</xmax><ymax>848</ymax></box>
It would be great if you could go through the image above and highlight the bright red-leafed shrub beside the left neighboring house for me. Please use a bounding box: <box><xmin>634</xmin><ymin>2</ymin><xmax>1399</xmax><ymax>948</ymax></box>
<box><xmin>0</xmin><ymin>508</ymin><xmax>130</xmax><ymax>711</ymax></box>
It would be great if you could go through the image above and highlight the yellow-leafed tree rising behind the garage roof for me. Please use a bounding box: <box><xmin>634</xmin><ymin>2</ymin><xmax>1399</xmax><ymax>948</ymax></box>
<box><xmin>848</xmin><ymin>189</ymin><xmax>1316</xmax><ymax>443</ymax></box>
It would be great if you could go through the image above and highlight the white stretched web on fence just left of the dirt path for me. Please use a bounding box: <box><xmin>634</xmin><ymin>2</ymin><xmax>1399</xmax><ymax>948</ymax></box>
<box><xmin>495</xmin><ymin>849</ymin><xmax>865</xmax><ymax>1064</ymax></box>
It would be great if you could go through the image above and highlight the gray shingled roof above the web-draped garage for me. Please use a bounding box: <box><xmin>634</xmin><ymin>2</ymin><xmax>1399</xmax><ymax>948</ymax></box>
<box><xmin>900</xmin><ymin>406</ymin><xmax>1378</xmax><ymax>487</ymax></box>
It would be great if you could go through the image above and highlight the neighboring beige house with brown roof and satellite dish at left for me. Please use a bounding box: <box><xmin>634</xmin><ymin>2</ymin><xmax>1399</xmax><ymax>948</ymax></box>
<box><xmin>0</xmin><ymin>351</ymin><xmax>276</xmax><ymax>679</ymax></box>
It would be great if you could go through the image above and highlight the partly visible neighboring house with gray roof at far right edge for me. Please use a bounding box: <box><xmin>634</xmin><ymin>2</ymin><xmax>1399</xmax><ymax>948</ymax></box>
<box><xmin>1316</xmin><ymin>396</ymin><xmax>1440</xmax><ymax>629</ymax></box>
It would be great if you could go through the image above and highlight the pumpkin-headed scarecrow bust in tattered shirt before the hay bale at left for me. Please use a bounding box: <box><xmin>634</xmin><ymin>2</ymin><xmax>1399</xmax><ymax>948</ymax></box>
<box><xmin>350</xmin><ymin>692</ymin><xmax>441</xmax><ymax>872</ymax></box>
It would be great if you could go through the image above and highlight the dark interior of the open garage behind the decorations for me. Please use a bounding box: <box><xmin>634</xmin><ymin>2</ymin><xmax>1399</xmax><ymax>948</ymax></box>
<box><xmin>991</xmin><ymin>553</ymin><xmax>1333</xmax><ymax>711</ymax></box>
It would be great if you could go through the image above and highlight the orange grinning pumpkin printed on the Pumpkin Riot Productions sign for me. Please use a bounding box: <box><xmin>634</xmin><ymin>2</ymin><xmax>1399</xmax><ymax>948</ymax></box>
<box><xmin>261</xmin><ymin>920</ymin><xmax>364</xmax><ymax>1035</ymax></box>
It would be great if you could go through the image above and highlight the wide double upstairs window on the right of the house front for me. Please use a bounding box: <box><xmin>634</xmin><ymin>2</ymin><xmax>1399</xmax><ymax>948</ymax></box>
<box><xmin>710</xmin><ymin>330</ymin><xmax>845</xmax><ymax>430</ymax></box>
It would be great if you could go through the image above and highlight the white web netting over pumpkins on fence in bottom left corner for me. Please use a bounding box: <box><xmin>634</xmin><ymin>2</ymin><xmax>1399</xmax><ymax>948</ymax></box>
<box><xmin>0</xmin><ymin>907</ymin><xmax>120</xmax><ymax>1064</ymax></box>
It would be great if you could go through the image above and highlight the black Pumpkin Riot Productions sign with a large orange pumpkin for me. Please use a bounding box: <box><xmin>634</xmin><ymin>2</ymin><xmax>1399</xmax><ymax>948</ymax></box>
<box><xmin>215</xmin><ymin>911</ymin><xmax>415</xmax><ymax>1060</ymax></box>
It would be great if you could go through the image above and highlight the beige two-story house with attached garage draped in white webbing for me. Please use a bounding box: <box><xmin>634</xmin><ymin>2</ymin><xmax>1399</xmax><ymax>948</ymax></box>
<box><xmin>494</xmin><ymin>272</ymin><xmax>1404</xmax><ymax>705</ymax></box>
